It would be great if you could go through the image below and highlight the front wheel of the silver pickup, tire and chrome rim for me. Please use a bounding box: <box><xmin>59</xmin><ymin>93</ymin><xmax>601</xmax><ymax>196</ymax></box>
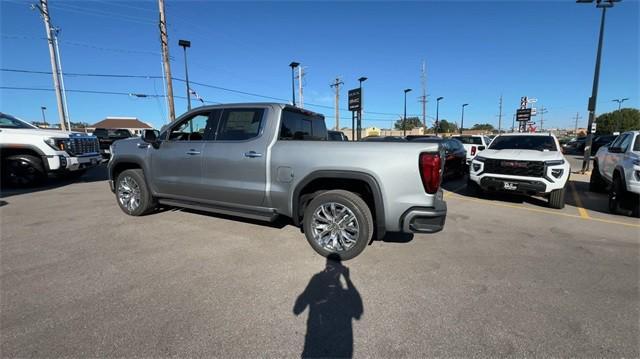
<box><xmin>115</xmin><ymin>169</ymin><xmax>157</xmax><ymax>216</ymax></box>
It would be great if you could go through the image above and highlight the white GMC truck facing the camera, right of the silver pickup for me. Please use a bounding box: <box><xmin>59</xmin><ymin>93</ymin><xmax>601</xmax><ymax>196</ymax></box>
<box><xmin>469</xmin><ymin>133</ymin><xmax>571</xmax><ymax>209</ymax></box>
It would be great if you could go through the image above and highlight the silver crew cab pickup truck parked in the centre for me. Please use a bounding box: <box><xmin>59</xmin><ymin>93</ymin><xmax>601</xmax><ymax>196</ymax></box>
<box><xmin>108</xmin><ymin>103</ymin><xmax>447</xmax><ymax>260</ymax></box>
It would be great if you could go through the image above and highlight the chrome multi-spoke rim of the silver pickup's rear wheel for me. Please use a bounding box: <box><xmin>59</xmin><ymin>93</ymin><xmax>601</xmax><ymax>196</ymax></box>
<box><xmin>311</xmin><ymin>202</ymin><xmax>359</xmax><ymax>252</ymax></box>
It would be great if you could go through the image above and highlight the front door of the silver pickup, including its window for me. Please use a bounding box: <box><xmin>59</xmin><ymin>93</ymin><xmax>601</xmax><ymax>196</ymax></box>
<box><xmin>149</xmin><ymin>110</ymin><xmax>212</xmax><ymax>198</ymax></box>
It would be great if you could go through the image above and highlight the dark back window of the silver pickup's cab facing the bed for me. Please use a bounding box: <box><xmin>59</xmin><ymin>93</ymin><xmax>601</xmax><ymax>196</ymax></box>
<box><xmin>278</xmin><ymin>108</ymin><xmax>327</xmax><ymax>141</ymax></box>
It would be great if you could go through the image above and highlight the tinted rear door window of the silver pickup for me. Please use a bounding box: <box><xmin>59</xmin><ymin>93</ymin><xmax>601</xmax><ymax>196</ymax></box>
<box><xmin>216</xmin><ymin>108</ymin><xmax>264</xmax><ymax>141</ymax></box>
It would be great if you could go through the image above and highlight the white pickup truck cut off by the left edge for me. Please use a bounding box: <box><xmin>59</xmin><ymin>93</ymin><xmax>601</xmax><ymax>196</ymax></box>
<box><xmin>0</xmin><ymin>112</ymin><xmax>101</xmax><ymax>186</ymax></box>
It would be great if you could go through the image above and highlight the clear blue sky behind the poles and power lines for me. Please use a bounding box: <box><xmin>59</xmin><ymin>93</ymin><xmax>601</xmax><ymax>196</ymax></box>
<box><xmin>0</xmin><ymin>0</ymin><xmax>640</xmax><ymax>128</ymax></box>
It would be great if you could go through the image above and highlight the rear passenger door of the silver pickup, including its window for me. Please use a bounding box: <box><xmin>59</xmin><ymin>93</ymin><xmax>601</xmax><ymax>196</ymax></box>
<box><xmin>202</xmin><ymin>108</ymin><xmax>271</xmax><ymax>206</ymax></box>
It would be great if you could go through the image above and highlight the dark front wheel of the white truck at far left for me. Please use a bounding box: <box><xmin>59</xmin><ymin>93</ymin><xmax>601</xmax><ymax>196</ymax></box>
<box><xmin>2</xmin><ymin>155</ymin><xmax>47</xmax><ymax>187</ymax></box>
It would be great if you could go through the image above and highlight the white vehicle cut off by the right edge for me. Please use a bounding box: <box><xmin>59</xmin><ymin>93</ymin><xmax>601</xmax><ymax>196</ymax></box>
<box><xmin>589</xmin><ymin>131</ymin><xmax>640</xmax><ymax>217</ymax></box>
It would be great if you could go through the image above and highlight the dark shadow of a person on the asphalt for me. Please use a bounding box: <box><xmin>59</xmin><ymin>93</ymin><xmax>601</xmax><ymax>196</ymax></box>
<box><xmin>293</xmin><ymin>256</ymin><xmax>364</xmax><ymax>358</ymax></box>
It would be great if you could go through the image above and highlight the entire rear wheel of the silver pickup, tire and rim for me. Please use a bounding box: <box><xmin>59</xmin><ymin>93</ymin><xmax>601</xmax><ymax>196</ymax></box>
<box><xmin>303</xmin><ymin>190</ymin><xmax>373</xmax><ymax>260</ymax></box>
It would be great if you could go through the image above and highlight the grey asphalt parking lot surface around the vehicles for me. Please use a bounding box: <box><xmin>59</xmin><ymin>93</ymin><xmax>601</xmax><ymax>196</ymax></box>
<box><xmin>0</xmin><ymin>168</ymin><xmax>640</xmax><ymax>357</ymax></box>
